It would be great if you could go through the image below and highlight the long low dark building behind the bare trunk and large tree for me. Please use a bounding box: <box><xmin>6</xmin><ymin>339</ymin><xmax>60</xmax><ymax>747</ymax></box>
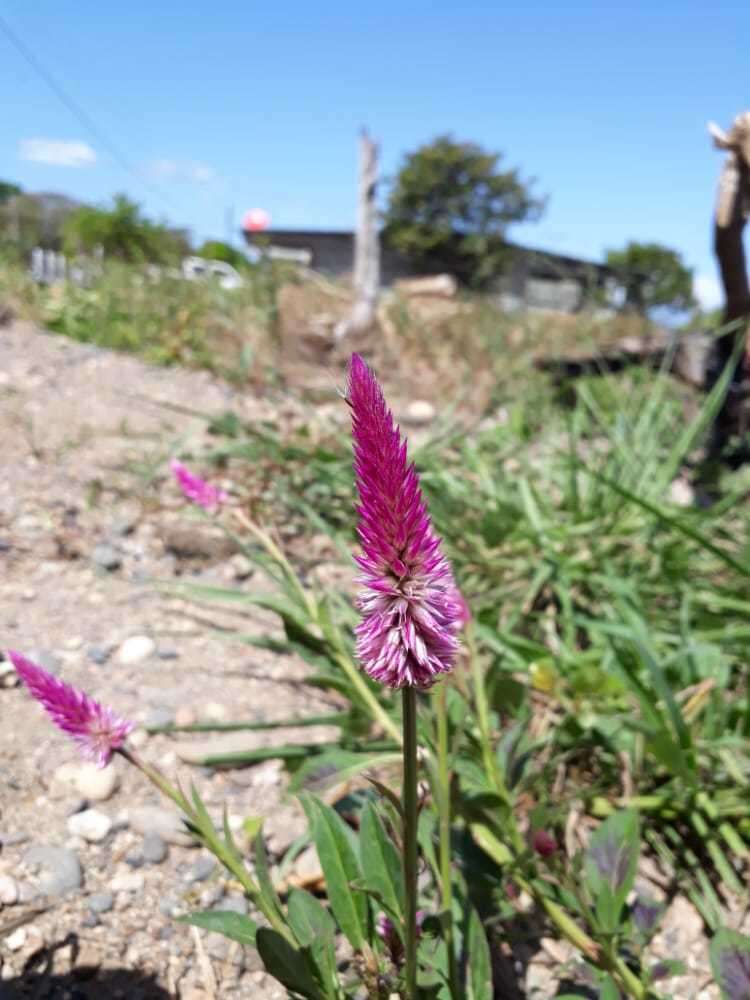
<box><xmin>245</xmin><ymin>229</ymin><xmax>626</xmax><ymax>312</ymax></box>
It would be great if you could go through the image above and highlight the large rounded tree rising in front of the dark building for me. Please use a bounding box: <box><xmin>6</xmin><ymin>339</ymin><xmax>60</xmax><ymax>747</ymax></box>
<box><xmin>383</xmin><ymin>135</ymin><xmax>544</xmax><ymax>286</ymax></box>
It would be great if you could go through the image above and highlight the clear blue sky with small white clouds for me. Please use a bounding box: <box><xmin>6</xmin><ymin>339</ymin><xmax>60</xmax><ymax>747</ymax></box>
<box><xmin>0</xmin><ymin>0</ymin><xmax>750</xmax><ymax>300</ymax></box>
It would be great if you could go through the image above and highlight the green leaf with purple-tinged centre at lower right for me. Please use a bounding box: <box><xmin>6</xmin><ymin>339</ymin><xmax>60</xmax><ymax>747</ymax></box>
<box><xmin>585</xmin><ymin>809</ymin><xmax>640</xmax><ymax>933</ymax></box>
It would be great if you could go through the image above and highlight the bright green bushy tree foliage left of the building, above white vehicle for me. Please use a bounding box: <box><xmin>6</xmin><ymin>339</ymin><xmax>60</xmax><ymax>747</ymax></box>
<box><xmin>63</xmin><ymin>194</ymin><xmax>190</xmax><ymax>264</ymax></box>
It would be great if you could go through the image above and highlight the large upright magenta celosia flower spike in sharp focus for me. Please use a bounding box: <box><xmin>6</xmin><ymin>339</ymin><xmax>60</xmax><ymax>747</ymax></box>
<box><xmin>347</xmin><ymin>354</ymin><xmax>466</xmax><ymax>688</ymax></box>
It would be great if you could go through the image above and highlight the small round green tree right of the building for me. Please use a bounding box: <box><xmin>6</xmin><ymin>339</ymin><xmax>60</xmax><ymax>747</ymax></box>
<box><xmin>607</xmin><ymin>242</ymin><xmax>696</xmax><ymax>313</ymax></box>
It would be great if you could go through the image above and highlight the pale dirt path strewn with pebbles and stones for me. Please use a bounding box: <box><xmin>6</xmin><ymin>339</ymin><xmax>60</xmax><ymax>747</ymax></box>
<box><xmin>0</xmin><ymin>325</ymin><xmax>336</xmax><ymax>1000</ymax></box>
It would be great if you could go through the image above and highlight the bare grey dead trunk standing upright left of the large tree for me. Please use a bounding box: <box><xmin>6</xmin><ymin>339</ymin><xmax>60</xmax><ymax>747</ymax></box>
<box><xmin>334</xmin><ymin>131</ymin><xmax>380</xmax><ymax>341</ymax></box>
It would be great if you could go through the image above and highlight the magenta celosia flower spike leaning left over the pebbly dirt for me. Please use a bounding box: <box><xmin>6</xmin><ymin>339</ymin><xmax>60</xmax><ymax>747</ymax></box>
<box><xmin>8</xmin><ymin>651</ymin><xmax>133</xmax><ymax>767</ymax></box>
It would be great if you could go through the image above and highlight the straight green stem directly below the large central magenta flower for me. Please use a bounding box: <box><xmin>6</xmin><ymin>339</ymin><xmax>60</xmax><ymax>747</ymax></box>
<box><xmin>402</xmin><ymin>687</ymin><xmax>417</xmax><ymax>1000</ymax></box>
